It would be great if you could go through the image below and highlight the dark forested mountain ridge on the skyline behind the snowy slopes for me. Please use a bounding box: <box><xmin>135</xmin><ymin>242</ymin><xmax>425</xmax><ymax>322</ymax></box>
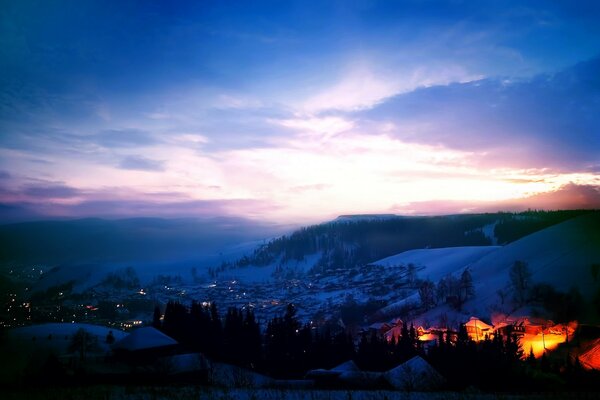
<box><xmin>215</xmin><ymin>211</ymin><xmax>589</xmax><ymax>275</ymax></box>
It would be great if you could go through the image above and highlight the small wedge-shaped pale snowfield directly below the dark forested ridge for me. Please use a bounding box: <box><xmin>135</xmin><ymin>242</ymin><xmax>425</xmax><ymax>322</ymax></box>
<box><xmin>371</xmin><ymin>246</ymin><xmax>501</xmax><ymax>282</ymax></box>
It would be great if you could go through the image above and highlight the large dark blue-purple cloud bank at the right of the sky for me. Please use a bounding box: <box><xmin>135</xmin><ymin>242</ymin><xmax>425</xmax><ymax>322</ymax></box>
<box><xmin>360</xmin><ymin>58</ymin><xmax>600</xmax><ymax>171</ymax></box>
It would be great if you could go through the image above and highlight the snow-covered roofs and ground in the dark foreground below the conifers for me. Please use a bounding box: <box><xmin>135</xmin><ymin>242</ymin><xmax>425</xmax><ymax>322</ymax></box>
<box><xmin>89</xmin><ymin>327</ymin><xmax>445</xmax><ymax>391</ymax></box>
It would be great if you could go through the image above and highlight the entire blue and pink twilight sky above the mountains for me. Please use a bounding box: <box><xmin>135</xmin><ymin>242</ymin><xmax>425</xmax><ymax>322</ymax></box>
<box><xmin>0</xmin><ymin>0</ymin><xmax>600</xmax><ymax>223</ymax></box>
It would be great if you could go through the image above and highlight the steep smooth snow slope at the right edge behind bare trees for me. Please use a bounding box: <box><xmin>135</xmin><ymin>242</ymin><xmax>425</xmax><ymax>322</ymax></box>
<box><xmin>470</xmin><ymin>212</ymin><xmax>600</xmax><ymax>315</ymax></box>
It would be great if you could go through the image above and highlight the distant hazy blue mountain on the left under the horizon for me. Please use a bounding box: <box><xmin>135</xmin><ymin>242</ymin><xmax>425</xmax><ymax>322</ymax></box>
<box><xmin>0</xmin><ymin>218</ymin><xmax>288</xmax><ymax>268</ymax></box>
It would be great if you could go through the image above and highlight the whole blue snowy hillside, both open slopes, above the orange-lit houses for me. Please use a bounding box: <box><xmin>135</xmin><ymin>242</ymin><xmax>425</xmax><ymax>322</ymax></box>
<box><xmin>371</xmin><ymin>212</ymin><xmax>600</xmax><ymax>323</ymax></box>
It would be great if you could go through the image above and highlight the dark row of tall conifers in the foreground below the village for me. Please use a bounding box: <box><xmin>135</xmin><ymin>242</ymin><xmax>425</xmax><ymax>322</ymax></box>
<box><xmin>153</xmin><ymin>302</ymin><xmax>591</xmax><ymax>390</ymax></box>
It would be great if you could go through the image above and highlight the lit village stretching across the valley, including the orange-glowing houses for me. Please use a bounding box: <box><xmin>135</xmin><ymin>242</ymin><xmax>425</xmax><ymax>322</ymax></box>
<box><xmin>0</xmin><ymin>265</ymin><xmax>577</xmax><ymax>358</ymax></box>
